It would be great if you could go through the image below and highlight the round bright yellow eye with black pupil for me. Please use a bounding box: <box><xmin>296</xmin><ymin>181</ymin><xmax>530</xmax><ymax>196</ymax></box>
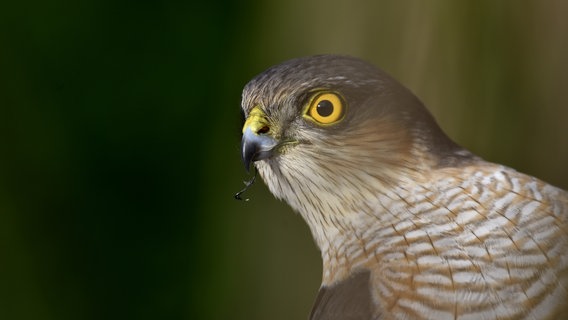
<box><xmin>306</xmin><ymin>92</ymin><xmax>345</xmax><ymax>124</ymax></box>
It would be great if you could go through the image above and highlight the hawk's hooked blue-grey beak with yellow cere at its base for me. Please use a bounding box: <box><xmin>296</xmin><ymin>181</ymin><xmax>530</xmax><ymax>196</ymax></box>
<box><xmin>241</xmin><ymin>107</ymin><xmax>278</xmax><ymax>172</ymax></box>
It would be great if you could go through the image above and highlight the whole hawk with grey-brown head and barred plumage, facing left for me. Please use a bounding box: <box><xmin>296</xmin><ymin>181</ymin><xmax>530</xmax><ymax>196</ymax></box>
<box><xmin>241</xmin><ymin>55</ymin><xmax>568</xmax><ymax>320</ymax></box>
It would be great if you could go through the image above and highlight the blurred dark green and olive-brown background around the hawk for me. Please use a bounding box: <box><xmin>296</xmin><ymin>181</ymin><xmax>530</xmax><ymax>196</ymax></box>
<box><xmin>0</xmin><ymin>0</ymin><xmax>568</xmax><ymax>320</ymax></box>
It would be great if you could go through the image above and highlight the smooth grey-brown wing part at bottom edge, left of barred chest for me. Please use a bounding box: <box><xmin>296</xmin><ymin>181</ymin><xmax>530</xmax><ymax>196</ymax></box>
<box><xmin>310</xmin><ymin>271</ymin><xmax>378</xmax><ymax>320</ymax></box>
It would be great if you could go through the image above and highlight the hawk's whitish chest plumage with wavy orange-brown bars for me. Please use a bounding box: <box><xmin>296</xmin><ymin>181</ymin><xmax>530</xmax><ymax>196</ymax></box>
<box><xmin>316</xmin><ymin>164</ymin><xmax>568</xmax><ymax>319</ymax></box>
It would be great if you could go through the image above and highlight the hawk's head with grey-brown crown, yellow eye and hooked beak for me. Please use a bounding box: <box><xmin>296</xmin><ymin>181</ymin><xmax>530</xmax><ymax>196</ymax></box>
<box><xmin>241</xmin><ymin>55</ymin><xmax>468</xmax><ymax>240</ymax></box>
